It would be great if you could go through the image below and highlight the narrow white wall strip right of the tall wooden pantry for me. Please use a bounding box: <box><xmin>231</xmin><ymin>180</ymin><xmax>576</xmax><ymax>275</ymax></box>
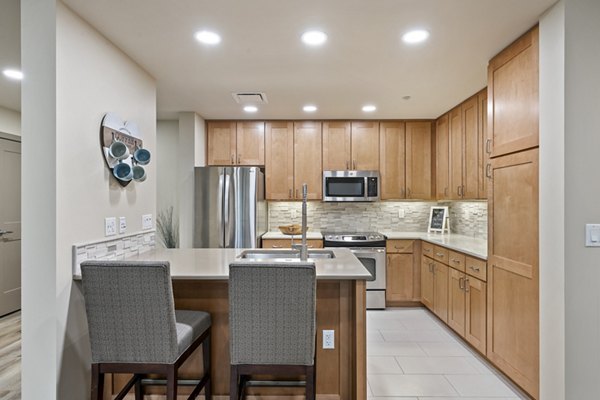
<box><xmin>539</xmin><ymin>1</ymin><xmax>565</xmax><ymax>399</ymax></box>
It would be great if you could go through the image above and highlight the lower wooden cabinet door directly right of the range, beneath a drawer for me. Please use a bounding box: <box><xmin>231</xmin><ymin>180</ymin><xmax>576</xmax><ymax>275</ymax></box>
<box><xmin>385</xmin><ymin>254</ymin><xmax>414</xmax><ymax>301</ymax></box>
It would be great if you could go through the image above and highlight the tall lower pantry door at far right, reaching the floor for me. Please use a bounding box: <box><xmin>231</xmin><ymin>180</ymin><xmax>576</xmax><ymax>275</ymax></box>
<box><xmin>487</xmin><ymin>149</ymin><xmax>539</xmax><ymax>398</ymax></box>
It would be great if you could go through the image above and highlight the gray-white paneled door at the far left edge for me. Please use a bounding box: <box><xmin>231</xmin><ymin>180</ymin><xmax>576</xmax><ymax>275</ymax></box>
<box><xmin>0</xmin><ymin>139</ymin><xmax>21</xmax><ymax>316</ymax></box>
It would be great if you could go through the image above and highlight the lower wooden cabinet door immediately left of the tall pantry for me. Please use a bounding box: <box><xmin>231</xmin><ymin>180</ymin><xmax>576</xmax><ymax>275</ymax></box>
<box><xmin>464</xmin><ymin>277</ymin><xmax>487</xmax><ymax>355</ymax></box>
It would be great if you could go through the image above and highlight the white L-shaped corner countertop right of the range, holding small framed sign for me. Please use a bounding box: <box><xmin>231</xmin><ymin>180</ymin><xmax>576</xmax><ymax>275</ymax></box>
<box><xmin>381</xmin><ymin>231</ymin><xmax>487</xmax><ymax>260</ymax></box>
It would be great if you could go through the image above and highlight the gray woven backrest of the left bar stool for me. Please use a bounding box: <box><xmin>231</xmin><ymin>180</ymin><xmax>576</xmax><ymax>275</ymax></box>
<box><xmin>81</xmin><ymin>261</ymin><xmax>178</xmax><ymax>363</ymax></box>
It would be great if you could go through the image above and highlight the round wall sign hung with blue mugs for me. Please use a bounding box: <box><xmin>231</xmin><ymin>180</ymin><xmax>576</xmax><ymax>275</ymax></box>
<box><xmin>100</xmin><ymin>113</ymin><xmax>151</xmax><ymax>186</ymax></box>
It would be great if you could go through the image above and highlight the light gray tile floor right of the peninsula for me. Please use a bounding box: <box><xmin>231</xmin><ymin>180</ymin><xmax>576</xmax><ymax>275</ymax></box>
<box><xmin>367</xmin><ymin>308</ymin><xmax>528</xmax><ymax>400</ymax></box>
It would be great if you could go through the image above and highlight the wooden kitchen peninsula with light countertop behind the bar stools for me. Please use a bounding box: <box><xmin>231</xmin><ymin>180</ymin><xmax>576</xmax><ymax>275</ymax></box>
<box><xmin>75</xmin><ymin>249</ymin><xmax>370</xmax><ymax>400</ymax></box>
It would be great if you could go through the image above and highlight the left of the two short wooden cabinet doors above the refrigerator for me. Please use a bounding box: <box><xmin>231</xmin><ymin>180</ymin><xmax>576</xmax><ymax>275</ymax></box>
<box><xmin>207</xmin><ymin>121</ymin><xmax>236</xmax><ymax>165</ymax></box>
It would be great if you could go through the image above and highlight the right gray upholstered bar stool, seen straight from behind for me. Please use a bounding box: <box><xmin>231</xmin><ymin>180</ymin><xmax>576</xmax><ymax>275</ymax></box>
<box><xmin>229</xmin><ymin>262</ymin><xmax>316</xmax><ymax>400</ymax></box>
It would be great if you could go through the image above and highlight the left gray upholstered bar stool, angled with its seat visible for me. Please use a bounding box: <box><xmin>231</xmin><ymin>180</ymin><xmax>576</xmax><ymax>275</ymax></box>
<box><xmin>81</xmin><ymin>261</ymin><xmax>211</xmax><ymax>400</ymax></box>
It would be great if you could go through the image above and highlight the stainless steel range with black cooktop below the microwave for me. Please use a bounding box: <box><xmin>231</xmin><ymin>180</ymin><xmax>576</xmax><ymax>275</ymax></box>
<box><xmin>323</xmin><ymin>232</ymin><xmax>386</xmax><ymax>309</ymax></box>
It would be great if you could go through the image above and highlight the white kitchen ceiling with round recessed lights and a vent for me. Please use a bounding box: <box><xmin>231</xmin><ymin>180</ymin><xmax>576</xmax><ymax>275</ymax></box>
<box><xmin>0</xmin><ymin>0</ymin><xmax>556</xmax><ymax>119</ymax></box>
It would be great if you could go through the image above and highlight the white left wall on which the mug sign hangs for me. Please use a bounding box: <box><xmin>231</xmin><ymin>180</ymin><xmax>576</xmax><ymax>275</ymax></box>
<box><xmin>22</xmin><ymin>0</ymin><xmax>156</xmax><ymax>400</ymax></box>
